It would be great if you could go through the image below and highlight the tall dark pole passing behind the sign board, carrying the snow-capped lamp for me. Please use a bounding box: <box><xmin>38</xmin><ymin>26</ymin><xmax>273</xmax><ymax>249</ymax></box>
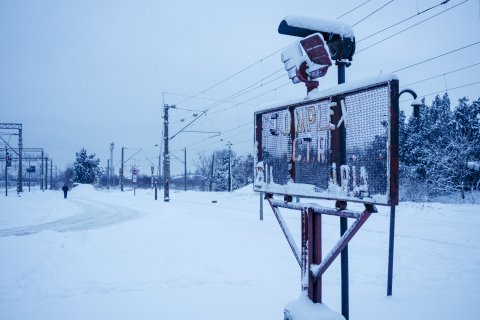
<box><xmin>336</xmin><ymin>61</ymin><xmax>350</xmax><ymax>320</ymax></box>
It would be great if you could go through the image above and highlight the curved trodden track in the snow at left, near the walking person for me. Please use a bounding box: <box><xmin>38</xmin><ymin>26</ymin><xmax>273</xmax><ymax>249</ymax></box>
<box><xmin>0</xmin><ymin>199</ymin><xmax>141</xmax><ymax>237</ymax></box>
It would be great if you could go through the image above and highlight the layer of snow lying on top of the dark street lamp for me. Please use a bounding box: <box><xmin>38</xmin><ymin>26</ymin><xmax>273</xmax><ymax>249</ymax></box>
<box><xmin>283</xmin><ymin>16</ymin><xmax>355</xmax><ymax>38</ymax></box>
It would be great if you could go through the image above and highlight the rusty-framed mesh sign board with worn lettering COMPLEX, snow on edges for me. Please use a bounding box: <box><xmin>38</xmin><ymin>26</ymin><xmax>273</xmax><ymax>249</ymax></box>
<box><xmin>254</xmin><ymin>75</ymin><xmax>399</xmax><ymax>205</ymax></box>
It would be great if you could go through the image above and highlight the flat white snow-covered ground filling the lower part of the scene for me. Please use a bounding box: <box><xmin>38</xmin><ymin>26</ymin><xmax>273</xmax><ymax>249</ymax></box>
<box><xmin>0</xmin><ymin>186</ymin><xmax>480</xmax><ymax>320</ymax></box>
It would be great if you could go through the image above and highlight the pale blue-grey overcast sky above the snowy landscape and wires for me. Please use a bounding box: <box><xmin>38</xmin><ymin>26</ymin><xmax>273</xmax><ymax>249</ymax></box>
<box><xmin>0</xmin><ymin>0</ymin><xmax>480</xmax><ymax>173</ymax></box>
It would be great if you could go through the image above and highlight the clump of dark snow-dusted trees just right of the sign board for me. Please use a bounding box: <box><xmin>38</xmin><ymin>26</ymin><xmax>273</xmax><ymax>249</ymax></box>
<box><xmin>400</xmin><ymin>94</ymin><xmax>480</xmax><ymax>198</ymax></box>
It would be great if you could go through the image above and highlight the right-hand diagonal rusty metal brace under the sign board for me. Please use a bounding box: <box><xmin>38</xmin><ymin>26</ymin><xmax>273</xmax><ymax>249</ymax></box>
<box><xmin>310</xmin><ymin>204</ymin><xmax>377</xmax><ymax>281</ymax></box>
